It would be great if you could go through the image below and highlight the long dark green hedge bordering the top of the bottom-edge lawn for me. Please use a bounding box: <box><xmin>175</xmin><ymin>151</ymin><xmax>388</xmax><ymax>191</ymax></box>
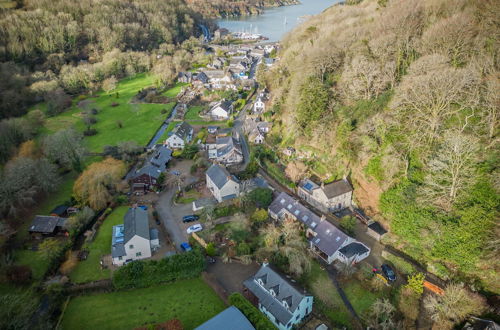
<box><xmin>113</xmin><ymin>249</ymin><xmax>205</xmax><ymax>289</ymax></box>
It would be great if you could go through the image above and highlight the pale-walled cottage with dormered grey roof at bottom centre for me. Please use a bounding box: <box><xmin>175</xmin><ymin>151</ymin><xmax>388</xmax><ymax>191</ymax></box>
<box><xmin>243</xmin><ymin>263</ymin><xmax>313</xmax><ymax>330</ymax></box>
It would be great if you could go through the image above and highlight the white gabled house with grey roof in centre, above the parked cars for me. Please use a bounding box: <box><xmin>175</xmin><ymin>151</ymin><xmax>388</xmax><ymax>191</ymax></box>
<box><xmin>206</xmin><ymin>164</ymin><xmax>240</xmax><ymax>203</ymax></box>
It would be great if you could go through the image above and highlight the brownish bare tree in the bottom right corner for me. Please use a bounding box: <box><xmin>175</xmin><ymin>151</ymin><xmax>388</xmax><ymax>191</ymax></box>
<box><xmin>424</xmin><ymin>284</ymin><xmax>486</xmax><ymax>324</ymax></box>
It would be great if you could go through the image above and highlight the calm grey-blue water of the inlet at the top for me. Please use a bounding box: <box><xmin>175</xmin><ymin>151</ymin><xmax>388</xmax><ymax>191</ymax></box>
<box><xmin>217</xmin><ymin>0</ymin><xmax>340</xmax><ymax>41</ymax></box>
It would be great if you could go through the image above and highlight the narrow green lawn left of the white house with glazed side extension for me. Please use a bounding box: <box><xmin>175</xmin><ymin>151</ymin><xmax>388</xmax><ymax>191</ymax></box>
<box><xmin>69</xmin><ymin>206</ymin><xmax>128</xmax><ymax>283</ymax></box>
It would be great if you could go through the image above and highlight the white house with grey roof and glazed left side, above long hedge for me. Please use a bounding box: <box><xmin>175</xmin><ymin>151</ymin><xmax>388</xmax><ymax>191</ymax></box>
<box><xmin>111</xmin><ymin>207</ymin><xmax>155</xmax><ymax>266</ymax></box>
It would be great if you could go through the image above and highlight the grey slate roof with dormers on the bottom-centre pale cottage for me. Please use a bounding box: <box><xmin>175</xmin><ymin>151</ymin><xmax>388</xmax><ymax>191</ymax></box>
<box><xmin>243</xmin><ymin>265</ymin><xmax>306</xmax><ymax>324</ymax></box>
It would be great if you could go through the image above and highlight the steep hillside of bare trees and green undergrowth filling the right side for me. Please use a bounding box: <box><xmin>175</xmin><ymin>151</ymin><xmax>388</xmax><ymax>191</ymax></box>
<box><xmin>264</xmin><ymin>0</ymin><xmax>500</xmax><ymax>292</ymax></box>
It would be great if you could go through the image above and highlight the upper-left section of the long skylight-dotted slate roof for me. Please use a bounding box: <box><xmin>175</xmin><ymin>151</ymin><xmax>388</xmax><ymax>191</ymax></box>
<box><xmin>269</xmin><ymin>192</ymin><xmax>321</xmax><ymax>230</ymax></box>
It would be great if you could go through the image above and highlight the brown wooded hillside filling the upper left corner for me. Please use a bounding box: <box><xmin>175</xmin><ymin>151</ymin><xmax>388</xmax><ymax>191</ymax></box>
<box><xmin>0</xmin><ymin>0</ymin><xmax>205</xmax><ymax>119</ymax></box>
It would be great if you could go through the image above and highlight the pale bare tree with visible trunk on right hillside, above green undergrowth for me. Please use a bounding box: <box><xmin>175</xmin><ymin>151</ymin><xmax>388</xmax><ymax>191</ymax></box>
<box><xmin>420</xmin><ymin>131</ymin><xmax>478</xmax><ymax>209</ymax></box>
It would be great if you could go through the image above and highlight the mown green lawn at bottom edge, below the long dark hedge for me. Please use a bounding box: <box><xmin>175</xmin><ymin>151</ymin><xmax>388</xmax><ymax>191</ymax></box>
<box><xmin>62</xmin><ymin>278</ymin><xmax>226</xmax><ymax>330</ymax></box>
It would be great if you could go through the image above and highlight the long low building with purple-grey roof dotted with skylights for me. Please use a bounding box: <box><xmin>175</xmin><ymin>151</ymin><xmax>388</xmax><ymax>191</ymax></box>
<box><xmin>268</xmin><ymin>192</ymin><xmax>370</xmax><ymax>264</ymax></box>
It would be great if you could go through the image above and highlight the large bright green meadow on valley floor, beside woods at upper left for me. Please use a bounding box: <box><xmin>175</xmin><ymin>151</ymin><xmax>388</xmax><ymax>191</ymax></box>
<box><xmin>40</xmin><ymin>74</ymin><xmax>176</xmax><ymax>152</ymax></box>
